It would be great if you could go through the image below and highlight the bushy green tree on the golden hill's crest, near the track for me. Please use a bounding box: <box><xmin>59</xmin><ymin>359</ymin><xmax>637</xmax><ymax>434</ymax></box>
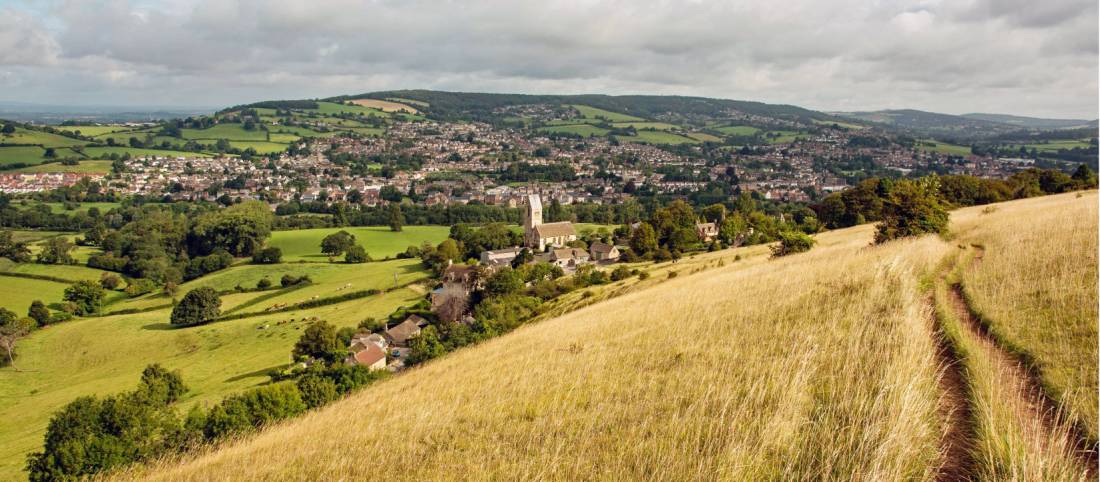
<box><xmin>875</xmin><ymin>177</ymin><xmax>948</xmax><ymax>243</ymax></box>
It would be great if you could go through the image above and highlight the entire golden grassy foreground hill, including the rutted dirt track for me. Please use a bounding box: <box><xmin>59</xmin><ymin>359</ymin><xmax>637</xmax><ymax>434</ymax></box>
<box><xmin>116</xmin><ymin>191</ymin><xmax>1097</xmax><ymax>481</ymax></box>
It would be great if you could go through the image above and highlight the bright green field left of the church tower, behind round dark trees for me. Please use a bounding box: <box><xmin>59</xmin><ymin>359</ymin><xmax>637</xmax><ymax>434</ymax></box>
<box><xmin>267</xmin><ymin>226</ymin><xmax>450</xmax><ymax>262</ymax></box>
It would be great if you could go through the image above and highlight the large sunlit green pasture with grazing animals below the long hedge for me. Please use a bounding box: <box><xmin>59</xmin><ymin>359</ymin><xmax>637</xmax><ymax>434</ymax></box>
<box><xmin>0</xmin><ymin>278</ymin><xmax>422</xmax><ymax>480</ymax></box>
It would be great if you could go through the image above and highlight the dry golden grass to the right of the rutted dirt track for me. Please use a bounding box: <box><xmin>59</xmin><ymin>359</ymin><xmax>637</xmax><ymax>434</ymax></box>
<box><xmin>956</xmin><ymin>191</ymin><xmax>1100</xmax><ymax>440</ymax></box>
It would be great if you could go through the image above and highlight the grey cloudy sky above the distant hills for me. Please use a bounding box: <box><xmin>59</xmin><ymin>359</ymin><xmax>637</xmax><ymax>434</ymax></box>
<box><xmin>0</xmin><ymin>0</ymin><xmax>1100</xmax><ymax>119</ymax></box>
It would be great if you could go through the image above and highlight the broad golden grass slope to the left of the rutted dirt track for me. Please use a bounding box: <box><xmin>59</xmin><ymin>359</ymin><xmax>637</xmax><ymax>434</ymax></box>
<box><xmin>120</xmin><ymin>193</ymin><xmax>1097</xmax><ymax>480</ymax></box>
